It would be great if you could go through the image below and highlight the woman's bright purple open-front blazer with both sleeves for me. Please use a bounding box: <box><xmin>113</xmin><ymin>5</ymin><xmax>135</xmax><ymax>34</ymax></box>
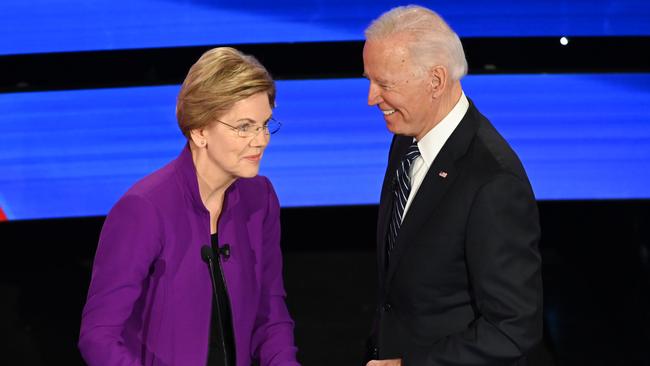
<box><xmin>79</xmin><ymin>146</ymin><xmax>298</xmax><ymax>366</ymax></box>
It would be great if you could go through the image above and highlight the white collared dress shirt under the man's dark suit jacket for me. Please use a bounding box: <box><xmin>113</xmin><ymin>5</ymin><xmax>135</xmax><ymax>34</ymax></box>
<box><xmin>402</xmin><ymin>92</ymin><xmax>469</xmax><ymax>221</ymax></box>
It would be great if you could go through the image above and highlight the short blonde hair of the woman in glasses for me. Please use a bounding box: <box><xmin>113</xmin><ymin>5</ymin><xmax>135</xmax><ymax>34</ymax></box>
<box><xmin>176</xmin><ymin>47</ymin><xmax>275</xmax><ymax>139</ymax></box>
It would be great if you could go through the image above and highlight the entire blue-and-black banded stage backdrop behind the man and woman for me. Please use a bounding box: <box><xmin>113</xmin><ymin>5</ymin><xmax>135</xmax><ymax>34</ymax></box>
<box><xmin>0</xmin><ymin>0</ymin><xmax>650</xmax><ymax>366</ymax></box>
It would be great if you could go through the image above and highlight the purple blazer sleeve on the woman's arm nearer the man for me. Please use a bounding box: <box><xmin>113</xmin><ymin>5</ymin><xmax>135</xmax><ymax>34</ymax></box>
<box><xmin>252</xmin><ymin>180</ymin><xmax>299</xmax><ymax>366</ymax></box>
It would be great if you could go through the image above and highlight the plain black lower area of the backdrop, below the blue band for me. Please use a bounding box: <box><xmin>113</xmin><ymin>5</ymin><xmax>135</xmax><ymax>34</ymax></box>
<box><xmin>0</xmin><ymin>201</ymin><xmax>650</xmax><ymax>366</ymax></box>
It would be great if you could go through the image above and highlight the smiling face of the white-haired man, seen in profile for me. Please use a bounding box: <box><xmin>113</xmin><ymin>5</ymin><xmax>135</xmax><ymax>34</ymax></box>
<box><xmin>363</xmin><ymin>35</ymin><xmax>436</xmax><ymax>139</ymax></box>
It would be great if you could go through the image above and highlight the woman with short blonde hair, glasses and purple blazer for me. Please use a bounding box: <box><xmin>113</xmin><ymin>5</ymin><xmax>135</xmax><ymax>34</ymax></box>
<box><xmin>79</xmin><ymin>48</ymin><xmax>298</xmax><ymax>366</ymax></box>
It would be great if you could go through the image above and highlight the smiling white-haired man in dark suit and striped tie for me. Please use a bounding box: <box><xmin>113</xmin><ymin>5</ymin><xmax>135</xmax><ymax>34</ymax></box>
<box><xmin>363</xmin><ymin>6</ymin><xmax>542</xmax><ymax>366</ymax></box>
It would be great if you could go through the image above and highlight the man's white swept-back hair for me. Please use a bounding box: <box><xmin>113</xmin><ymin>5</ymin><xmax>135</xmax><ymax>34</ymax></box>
<box><xmin>365</xmin><ymin>5</ymin><xmax>467</xmax><ymax>80</ymax></box>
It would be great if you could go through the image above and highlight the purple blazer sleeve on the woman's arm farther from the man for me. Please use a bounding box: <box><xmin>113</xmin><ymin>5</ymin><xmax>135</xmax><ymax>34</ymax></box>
<box><xmin>79</xmin><ymin>195</ymin><xmax>161</xmax><ymax>366</ymax></box>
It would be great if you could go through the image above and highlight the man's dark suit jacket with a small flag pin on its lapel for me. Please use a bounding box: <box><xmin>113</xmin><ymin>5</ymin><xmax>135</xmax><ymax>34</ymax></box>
<box><xmin>370</xmin><ymin>102</ymin><xmax>542</xmax><ymax>366</ymax></box>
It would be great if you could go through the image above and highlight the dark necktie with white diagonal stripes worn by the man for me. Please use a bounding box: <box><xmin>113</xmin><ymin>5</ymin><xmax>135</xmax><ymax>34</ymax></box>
<box><xmin>387</xmin><ymin>141</ymin><xmax>420</xmax><ymax>257</ymax></box>
